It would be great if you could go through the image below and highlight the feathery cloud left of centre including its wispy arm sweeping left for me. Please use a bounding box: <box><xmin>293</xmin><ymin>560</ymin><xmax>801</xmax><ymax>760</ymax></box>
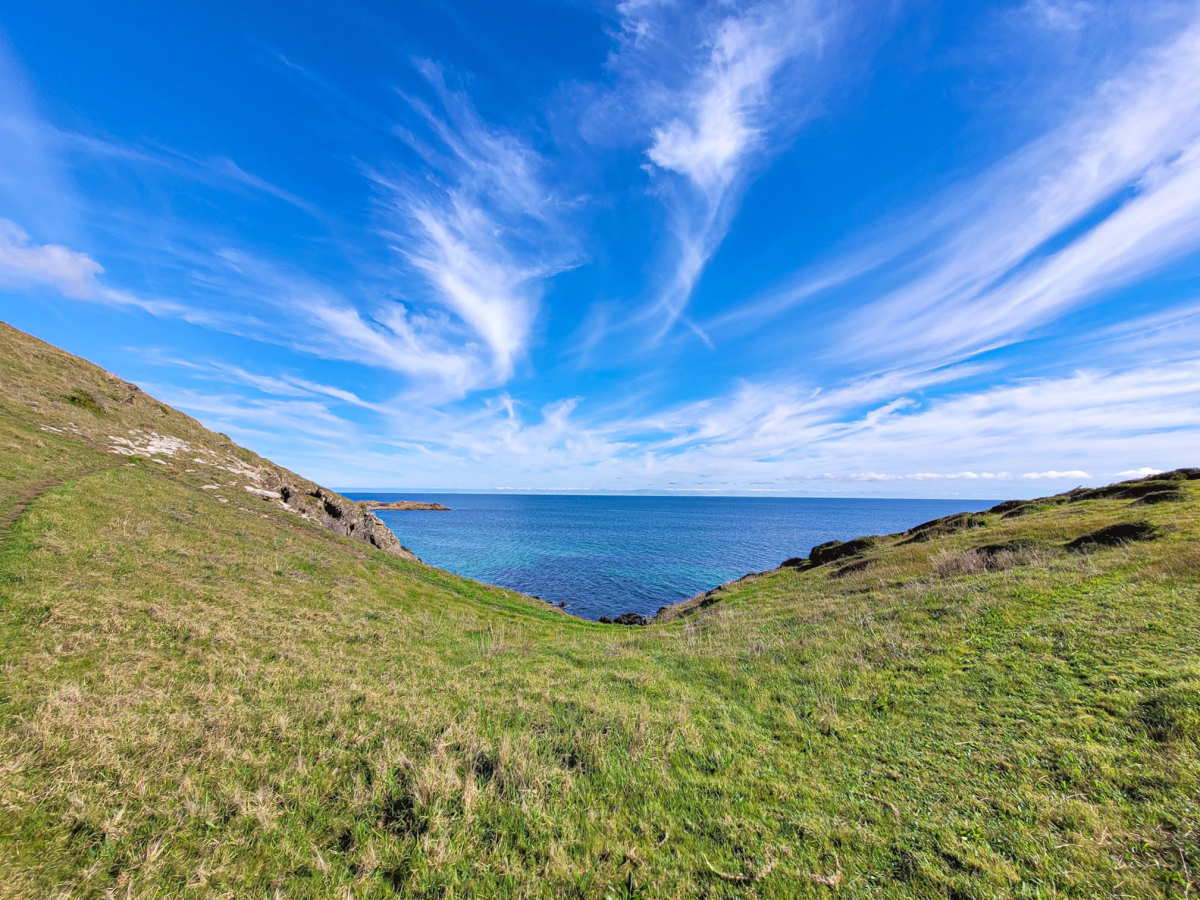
<box><xmin>114</xmin><ymin>61</ymin><xmax>577</xmax><ymax>409</ymax></box>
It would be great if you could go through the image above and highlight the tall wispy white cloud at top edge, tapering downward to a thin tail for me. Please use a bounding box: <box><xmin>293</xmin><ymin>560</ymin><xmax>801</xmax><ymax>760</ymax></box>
<box><xmin>613</xmin><ymin>0</ymin><xmax>829</xmax><ymax>341</ymax></box>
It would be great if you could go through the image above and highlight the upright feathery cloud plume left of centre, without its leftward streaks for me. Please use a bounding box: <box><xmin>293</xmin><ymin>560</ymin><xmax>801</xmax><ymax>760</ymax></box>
<box><xmin>370</xmin><ymin>61</ymin><xmax>578</xmax><ymax>390</ymax></box>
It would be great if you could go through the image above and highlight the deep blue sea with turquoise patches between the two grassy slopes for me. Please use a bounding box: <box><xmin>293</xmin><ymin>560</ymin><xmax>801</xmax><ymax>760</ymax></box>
<box><xmin>347</xmin><ymin>492</ymin><xmax>992</xmax><ymax>619</ymax></box>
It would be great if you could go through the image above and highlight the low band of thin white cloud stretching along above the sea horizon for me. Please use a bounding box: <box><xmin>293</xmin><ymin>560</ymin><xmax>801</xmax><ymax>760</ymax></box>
<box><xmin>180</xmin><ymin>345</ymin><xmax>1200</xmax><ymax>497</ymax></box>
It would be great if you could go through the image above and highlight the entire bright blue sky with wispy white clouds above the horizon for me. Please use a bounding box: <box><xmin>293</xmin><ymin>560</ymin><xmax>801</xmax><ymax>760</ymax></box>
<box><xmin>0</xmin><ymin>0</ymin><xmax>1200</xmax><ymax>498</ymax></box>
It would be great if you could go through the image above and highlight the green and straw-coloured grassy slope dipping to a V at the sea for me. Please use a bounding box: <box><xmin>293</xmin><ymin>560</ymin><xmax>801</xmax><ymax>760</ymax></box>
<box><xmin>0</xmin><ymin>329</ymin><xmax>1200</xmax><ymax>898</ymax></box>
